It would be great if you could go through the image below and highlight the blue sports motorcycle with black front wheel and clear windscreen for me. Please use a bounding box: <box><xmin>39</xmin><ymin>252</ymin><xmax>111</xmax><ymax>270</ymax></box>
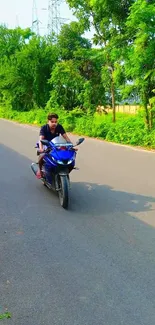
<box><xmin>31</xmin><ymin>136</ymin><xmax>85</xmax><ymax>209</ymax></box>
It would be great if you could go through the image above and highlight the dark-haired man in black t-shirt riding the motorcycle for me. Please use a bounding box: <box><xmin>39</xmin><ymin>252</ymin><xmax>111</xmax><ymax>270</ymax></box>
<box><xmin>36</xmin><ymin>113</ymin><xmax>72</xmax><ymax>178</ymax></box>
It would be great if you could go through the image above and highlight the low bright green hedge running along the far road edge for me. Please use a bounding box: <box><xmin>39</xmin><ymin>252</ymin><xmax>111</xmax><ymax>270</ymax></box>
<box><xmin>0</xmin><ymin>108</ymin><xmax>155</xmax><ymax>149</ymax></box>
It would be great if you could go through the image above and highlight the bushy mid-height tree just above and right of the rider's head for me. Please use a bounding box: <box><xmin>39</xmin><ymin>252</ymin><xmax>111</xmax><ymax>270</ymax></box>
<box><xmin>53</xmin><ymin>22</ymin><xmax>105</xmax><ymax>111</ymax></box>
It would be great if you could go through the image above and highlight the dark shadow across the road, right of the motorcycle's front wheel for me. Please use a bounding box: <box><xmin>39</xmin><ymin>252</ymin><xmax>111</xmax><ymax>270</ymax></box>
<box><xmin>72</xmin><ymin>182</ymin><xmax>155</xmax><ymax>217</ymax></box>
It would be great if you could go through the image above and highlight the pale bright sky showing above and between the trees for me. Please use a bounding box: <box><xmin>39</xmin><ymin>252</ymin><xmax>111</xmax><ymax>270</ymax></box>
<box><xmin>0</xmin><ymin>0</ymin><xmax>91</xmax><ymax>38</ymax></box>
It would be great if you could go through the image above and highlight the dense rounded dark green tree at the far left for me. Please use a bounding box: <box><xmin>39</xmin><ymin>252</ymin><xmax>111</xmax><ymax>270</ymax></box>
<box><xmin>0</xmin><ymin>31</ymin><xmax>58</xmax><ymax>110</ymax></box>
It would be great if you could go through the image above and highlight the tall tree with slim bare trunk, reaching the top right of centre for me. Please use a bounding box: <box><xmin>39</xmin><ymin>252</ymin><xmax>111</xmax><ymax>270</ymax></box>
<box><xmin>67</xmin><ymin>0</ymin><xmax>133</xmax><ymax>122</ymax></box>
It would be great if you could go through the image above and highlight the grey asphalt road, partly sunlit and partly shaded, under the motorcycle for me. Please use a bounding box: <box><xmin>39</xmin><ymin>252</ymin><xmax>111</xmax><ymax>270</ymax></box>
<box><xmin>0</xmin><ymin>120</ymin><xmax>155</xmax><ymax>325</ymax></box>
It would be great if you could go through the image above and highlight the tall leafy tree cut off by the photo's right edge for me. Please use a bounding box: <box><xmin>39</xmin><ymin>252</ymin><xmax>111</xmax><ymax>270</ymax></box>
<box><xmin>126</xmin><ymin>0</ymin><xmax>155</xmax><ymax>128</ymax></box>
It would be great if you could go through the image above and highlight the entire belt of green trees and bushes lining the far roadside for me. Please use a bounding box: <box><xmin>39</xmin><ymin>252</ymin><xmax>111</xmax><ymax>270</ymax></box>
<box><xmin>0</xmin><ymin>0</ymin><xmax>155</xmax><ymax>148</ymax></box>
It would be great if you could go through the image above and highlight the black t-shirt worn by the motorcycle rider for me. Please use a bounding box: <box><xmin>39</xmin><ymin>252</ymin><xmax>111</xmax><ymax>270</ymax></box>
<box><xmin>40</xmin><ymin>124</ymin><xmax>66</xmax><ymax>141</ymax></box>
